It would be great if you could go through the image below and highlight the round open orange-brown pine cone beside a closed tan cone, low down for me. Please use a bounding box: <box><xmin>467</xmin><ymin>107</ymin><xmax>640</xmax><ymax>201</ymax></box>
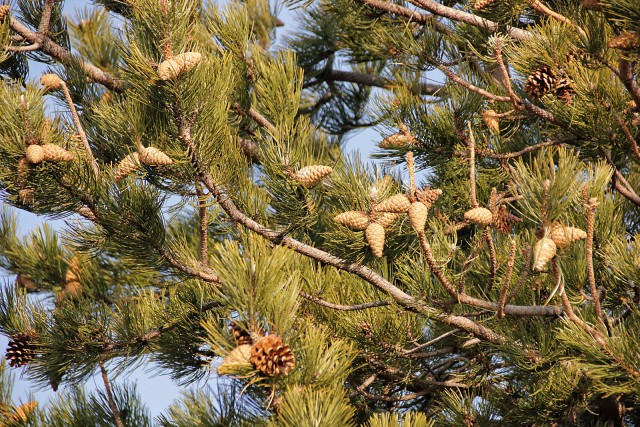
<box><xmin>251</xmin><ymin>335</ymin><xmax>296</xmax><ymax>377</ymax></box>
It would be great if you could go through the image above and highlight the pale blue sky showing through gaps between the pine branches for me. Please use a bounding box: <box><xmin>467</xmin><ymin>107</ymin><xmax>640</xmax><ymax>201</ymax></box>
<box><xmin>0</xmin><ymin>0</ymin><xmax>396</xmax><ymax>422</ymax></box>
